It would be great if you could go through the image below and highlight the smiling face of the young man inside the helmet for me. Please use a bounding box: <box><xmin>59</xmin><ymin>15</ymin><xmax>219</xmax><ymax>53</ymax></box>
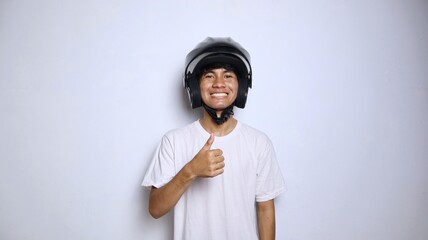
<box><xmin>199</xmin><ymin>68</ymin><xmax>238</xmax><ymax>110</ymax></box>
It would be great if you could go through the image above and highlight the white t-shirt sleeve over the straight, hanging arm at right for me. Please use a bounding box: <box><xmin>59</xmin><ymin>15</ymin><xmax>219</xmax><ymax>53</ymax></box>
<box><xmin>256</xmin><ymin>136</ymin><xmax>286</xmax><ymax>202</ymax></box>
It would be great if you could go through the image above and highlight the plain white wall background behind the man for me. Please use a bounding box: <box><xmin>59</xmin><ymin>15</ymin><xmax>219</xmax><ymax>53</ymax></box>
<box><xmin>0</xmin><ymin>0</ymin><xmax>428</xmax><ymax>240</ymax></box>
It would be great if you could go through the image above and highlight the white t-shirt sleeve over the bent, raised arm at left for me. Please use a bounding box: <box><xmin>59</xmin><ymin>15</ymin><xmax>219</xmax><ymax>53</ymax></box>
<box><xmin>141</xmin><ymin>135</ymin><xmax>175</xmax><ymax>188</ymax></box>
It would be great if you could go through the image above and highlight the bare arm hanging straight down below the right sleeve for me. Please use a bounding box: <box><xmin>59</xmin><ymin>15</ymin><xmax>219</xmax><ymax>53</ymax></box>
<box><xmin>257</xmin><ymin>199</ymin><xmax>275</xmax><ymax>240</ymax></box>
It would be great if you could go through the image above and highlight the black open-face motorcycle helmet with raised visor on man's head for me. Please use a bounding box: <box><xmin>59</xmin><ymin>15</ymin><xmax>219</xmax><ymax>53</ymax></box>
<box><xmin>183</xmin><ymin>37</ymin><xmax>252</xmax><ymax>108</ymax></box>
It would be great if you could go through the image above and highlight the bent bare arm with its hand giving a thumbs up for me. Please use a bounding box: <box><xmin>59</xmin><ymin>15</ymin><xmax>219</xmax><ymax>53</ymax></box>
<box><xmin>149</xmin><ymin>134</ymin><xmax>224</xmax><ymax>218</ymax></box>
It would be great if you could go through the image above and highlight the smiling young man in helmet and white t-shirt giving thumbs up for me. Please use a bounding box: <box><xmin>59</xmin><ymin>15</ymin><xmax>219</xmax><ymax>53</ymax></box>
<box><xmin>143</xmin><ymin>38</ymin><xmax>285</xmax><ymax>240</ymax></box>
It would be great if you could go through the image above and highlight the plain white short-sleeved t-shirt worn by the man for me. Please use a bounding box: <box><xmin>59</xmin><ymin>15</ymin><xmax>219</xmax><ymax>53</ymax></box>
<box><xmin>142</xmin><ymin>121</ymin><xmax>285</xmax><ymax>240</ymax></box>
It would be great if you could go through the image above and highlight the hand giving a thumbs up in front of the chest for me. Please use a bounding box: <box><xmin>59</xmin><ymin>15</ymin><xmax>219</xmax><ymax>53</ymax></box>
<box><xmin>189</xmin><ymin>133</ymin><xmax>224</xmax><ymax>177</ymax></box>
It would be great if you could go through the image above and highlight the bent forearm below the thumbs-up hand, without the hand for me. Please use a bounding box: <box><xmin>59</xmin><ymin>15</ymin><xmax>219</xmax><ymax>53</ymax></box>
<box><xmin>149</xmin><ymin>166</ymin><xmax>195</xmax><ymax>218</ymax></box>
